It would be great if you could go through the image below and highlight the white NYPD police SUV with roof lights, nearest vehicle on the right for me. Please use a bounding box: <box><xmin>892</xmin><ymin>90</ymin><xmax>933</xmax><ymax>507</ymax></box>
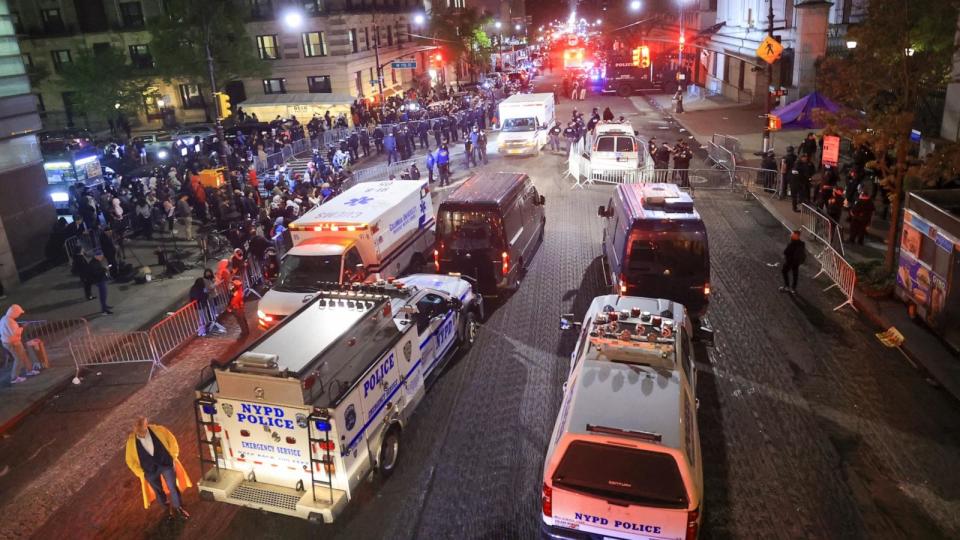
<box><xmin>541</xmin><ymin>295</ymin><xmax>707</xmax><ymax>540</ymax></box>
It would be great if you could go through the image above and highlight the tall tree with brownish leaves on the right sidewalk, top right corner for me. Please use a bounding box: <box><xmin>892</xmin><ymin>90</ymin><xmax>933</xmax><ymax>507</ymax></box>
<box><xmin>817</xmin><ymin>0</ymin><xmax>958</xmax><ymax>270</ymax></box>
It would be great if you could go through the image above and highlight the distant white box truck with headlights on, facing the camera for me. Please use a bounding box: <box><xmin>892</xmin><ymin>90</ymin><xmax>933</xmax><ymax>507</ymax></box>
<box><xmin>497</xmin><ymin>94</ymin><xmax>556</xmax><ymax>155</ymax></box>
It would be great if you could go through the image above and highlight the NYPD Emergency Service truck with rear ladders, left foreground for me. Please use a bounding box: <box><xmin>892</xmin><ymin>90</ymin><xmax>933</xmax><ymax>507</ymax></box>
<box><xmin>195</xmin><ymin>274</ymin><xmax>483</xmax><ymax>523</ymax></box>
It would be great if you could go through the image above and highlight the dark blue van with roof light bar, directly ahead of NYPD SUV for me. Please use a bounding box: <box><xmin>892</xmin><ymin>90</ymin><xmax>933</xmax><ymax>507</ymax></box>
<box><xmin>597</xmin><ymin>184</ymin><xmax>710</xmax><ymax>319</ymax></box>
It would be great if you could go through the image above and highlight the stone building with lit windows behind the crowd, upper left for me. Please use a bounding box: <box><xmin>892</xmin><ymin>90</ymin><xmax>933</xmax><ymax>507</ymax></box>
<box><xmin>8</xmin><ymin>0</ymin><xmax>444</xmax><ymax>129</ymax></box>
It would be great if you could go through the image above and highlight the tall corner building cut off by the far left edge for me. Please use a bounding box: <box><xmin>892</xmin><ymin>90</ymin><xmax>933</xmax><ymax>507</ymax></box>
<box><xmin>0</xmin><ymin>0</ymin><xmax>55</xmax><ymax>286</ymax></box>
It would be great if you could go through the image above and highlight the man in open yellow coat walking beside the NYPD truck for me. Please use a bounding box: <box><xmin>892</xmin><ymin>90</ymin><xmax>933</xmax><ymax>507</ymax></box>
<box><xmin>126</xmin><ymin>416</ymin><xmax>193</xmax><ymax>518</ymax></box>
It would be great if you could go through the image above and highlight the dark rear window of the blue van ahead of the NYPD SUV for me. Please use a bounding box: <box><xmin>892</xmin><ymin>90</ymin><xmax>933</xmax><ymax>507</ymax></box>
<box><xmin>627</xmin><ymin>230</ymin><xmax>709</xmax><ymax>279</ymax></box>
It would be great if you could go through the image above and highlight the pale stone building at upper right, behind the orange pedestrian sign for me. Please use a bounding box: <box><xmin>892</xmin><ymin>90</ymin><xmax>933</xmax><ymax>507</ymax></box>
<box><xmin>694</xmin><ymin>0</ymin><xmax>867</xmax><ymax>103</ymax></box>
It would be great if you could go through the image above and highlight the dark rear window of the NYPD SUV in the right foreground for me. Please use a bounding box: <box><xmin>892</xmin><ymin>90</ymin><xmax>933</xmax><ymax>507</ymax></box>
<box><xmin>553</xmin><ymin>441</ymin><xmax>688</xmax><ymax>508</ymax></box>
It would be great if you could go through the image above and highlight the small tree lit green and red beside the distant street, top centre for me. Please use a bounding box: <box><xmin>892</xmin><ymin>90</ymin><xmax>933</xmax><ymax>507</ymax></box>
<box><xmin>427</xmin><ymin>6</ymin><xmax>491</xmax><ymax>80</ymax></box>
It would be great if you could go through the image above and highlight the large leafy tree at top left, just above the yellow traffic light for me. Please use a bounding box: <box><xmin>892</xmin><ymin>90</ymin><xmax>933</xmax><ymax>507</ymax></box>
<box><xmin>147</xmin><ymin>0</ymin><xmax>270</xmax><ymax>95</ymax></box>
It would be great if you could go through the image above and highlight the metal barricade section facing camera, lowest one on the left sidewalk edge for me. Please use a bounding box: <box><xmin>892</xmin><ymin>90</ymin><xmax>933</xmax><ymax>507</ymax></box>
<box><xmin>70</xmin><ymin>332</ymin><xmax>166</xmax><ymax>378</ymax></box>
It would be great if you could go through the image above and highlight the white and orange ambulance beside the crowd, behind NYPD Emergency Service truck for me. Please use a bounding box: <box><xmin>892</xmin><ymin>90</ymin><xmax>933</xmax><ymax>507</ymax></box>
<box><xmin>257</xmin><ymin>180</ymin><xmax>436</xmax><ymax>328</ymax></box>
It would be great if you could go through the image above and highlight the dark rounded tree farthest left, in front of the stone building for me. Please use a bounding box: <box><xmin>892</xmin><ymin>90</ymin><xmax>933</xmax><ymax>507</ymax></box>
<box><xmin>58</xmin><ymin>47</ymin><xmax>152</xmax><ymax>125</ymax></box>
